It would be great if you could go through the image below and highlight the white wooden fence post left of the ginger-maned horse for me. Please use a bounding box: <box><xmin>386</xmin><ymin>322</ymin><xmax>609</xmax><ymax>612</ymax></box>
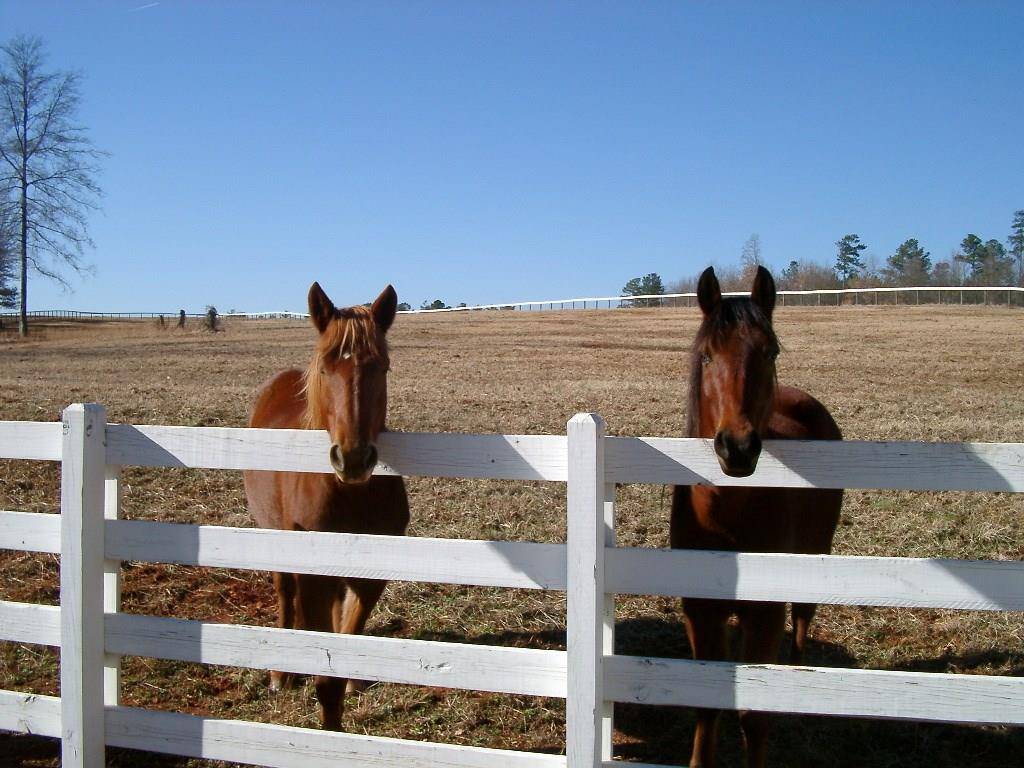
<box><xmin>60</xmin><ymin>403</ymin><xmax>106</xmax><ymax>768</ymax></box>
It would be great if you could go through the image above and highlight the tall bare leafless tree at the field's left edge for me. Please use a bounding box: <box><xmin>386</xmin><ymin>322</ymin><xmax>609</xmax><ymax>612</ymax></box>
<box><xmin>0</xmin><ymin>36</ymin><xmax>104</xmax><ymax>336</ymax></box>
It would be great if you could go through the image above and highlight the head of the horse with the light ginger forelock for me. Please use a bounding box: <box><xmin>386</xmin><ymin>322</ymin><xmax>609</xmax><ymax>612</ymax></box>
<box><xmin>306</xmin><ymin>283</ymin><xmax>397</xmax><ymax>483</ymax></box>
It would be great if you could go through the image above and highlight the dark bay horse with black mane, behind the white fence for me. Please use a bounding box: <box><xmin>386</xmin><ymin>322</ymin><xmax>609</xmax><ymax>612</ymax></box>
<box><xmin>671</xmin><ymin>266</ymin><xmax>843</xmax><ymax>768</ymax></box>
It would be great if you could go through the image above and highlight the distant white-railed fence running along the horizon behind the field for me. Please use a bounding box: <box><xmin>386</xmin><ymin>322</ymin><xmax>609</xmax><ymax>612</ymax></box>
<box><xmin>6</xmin><ymin>286</ymin><xmax>1024</xmax><ymax>323</ymax></box>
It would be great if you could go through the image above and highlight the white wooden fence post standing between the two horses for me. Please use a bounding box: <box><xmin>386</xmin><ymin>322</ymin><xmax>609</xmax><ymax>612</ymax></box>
<box><xmin>565</xmin><ymin>414</ymin><xmax>614</xmax><ymax>768</ymax></box>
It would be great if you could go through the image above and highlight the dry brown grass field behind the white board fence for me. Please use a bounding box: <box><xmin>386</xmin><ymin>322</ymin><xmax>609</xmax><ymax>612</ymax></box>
<box><xmin>0</xmin><ymin>306</ymin><xmax>1024</xmax><ymax>768</ymax></box>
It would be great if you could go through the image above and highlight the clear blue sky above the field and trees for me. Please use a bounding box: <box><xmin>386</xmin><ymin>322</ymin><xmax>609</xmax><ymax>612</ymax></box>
<box><xmin>0</xmin><ymin>0</ymin><xmax>1024</xmax><ymax>311</ymax></box>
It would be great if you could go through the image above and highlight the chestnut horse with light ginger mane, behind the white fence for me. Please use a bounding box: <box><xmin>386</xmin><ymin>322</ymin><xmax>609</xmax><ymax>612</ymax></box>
<box><xmin>245</xmin><ymin>283</ymin><xmax>409</xmax><ymax>730</ymax></box>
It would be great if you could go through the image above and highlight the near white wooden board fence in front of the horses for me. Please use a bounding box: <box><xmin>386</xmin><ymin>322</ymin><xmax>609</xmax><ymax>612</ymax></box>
<box><xmin>0</xmin><ymin>406</ymin><xmax>1024</xmax><ymax>768</ymax></box>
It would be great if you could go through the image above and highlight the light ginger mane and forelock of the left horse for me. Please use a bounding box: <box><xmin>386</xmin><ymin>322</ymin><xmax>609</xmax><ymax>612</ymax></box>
<box><xmin>302</xmin><ymin>306</ymin><xmax>387</xmax><ymax>429</ymax></box>
